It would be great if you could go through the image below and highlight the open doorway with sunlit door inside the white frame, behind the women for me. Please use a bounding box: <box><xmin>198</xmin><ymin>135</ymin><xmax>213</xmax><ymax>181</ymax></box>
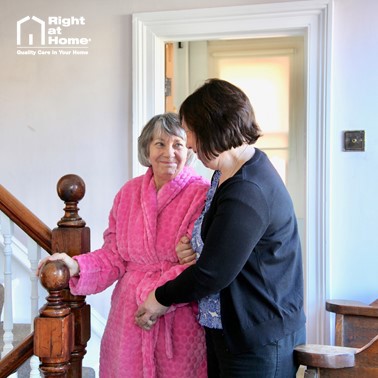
<box><xmin>165</xmin><ymin>36</ymin><xmax>306</xmax><ymax>256</ymax></box>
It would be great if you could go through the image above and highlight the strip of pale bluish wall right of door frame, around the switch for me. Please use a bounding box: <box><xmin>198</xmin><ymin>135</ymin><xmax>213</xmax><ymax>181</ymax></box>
<box><xmin>330</xmin><ymin>0</ymin><xmax>378</xmax><ymax>302</ymax></box>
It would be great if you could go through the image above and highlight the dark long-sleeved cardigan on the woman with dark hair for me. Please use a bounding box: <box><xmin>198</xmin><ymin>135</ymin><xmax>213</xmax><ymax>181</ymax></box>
<box><xmin>156</xmin><ymin>149</ymin><xmax>305</xmax><ymax>353</ymax></box>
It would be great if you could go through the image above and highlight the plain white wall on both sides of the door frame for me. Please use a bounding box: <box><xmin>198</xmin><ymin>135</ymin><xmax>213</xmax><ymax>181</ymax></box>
<box><xmin>0</xmin><ymin>0</ymin><xmax>378</xmax><ymax>372</ymax></box>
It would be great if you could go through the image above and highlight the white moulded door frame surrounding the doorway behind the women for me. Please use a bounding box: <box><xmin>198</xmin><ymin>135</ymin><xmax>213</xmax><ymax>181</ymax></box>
<box><xmin>132</xmin><ymin>0</ymin><xmax>333</xmax><ymax>343</ymax></box>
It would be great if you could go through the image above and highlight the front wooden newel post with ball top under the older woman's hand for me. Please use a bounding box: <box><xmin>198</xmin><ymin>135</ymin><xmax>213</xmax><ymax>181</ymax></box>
<box><xmin>34</xmin><ymin>261</ymin><xmax>74</xmax><ymax>377</ymax></box>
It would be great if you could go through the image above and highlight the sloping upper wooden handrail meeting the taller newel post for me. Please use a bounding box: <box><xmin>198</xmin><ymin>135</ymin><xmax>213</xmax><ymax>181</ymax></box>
<box><xmin>0</xmin><ymin>185</ymin><xmax>51</xmax><ymax>253</ymax></box>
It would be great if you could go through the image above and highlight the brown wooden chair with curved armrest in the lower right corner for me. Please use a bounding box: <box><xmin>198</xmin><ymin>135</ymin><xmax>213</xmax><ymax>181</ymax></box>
<box><xmin>294</xmin><ymin>300</ymin><xmax>378</xmax><ymax>378</ymax></box>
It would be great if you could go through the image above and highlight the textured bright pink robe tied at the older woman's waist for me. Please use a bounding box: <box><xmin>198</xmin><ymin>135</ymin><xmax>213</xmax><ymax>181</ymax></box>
<box><xmin>70</xmin><ymin>167</ymin><xmax>208</xmax><ymax>378</ymax></box>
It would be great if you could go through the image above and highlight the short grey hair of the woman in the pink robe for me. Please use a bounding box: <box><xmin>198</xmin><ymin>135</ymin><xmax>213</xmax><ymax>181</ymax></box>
<box><xmin>138</xmin><ymin>113</ymin><xmax>195</xmax><ymax>167</ymax></box>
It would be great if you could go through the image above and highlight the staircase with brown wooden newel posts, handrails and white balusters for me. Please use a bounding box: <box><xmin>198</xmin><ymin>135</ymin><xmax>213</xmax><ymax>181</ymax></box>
<box><xmin>0</xmin><ymin>175</ymin><xmax>96</xmax><ymax>378</ymax></box>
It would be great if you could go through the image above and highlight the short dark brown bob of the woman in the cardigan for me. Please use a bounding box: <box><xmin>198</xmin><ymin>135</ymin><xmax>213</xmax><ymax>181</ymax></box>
<box><xmin>179</xmin><ymin>79</ymin><xmax>261</xmax><ymax>160</ymax></box>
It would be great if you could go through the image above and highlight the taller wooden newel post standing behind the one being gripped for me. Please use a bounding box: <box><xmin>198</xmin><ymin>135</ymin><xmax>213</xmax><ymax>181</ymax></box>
<box><xmin>51</xmin><ymin>174</ymin><xmax>90</xmax><ymax>378</ymax></box>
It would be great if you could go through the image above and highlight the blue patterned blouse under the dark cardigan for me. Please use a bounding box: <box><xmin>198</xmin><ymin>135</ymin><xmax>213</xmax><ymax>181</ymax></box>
<box><xmin>191</xmin><ymin>171</ymin><xmax>222</xmax><ymax>329</ymax></box>
